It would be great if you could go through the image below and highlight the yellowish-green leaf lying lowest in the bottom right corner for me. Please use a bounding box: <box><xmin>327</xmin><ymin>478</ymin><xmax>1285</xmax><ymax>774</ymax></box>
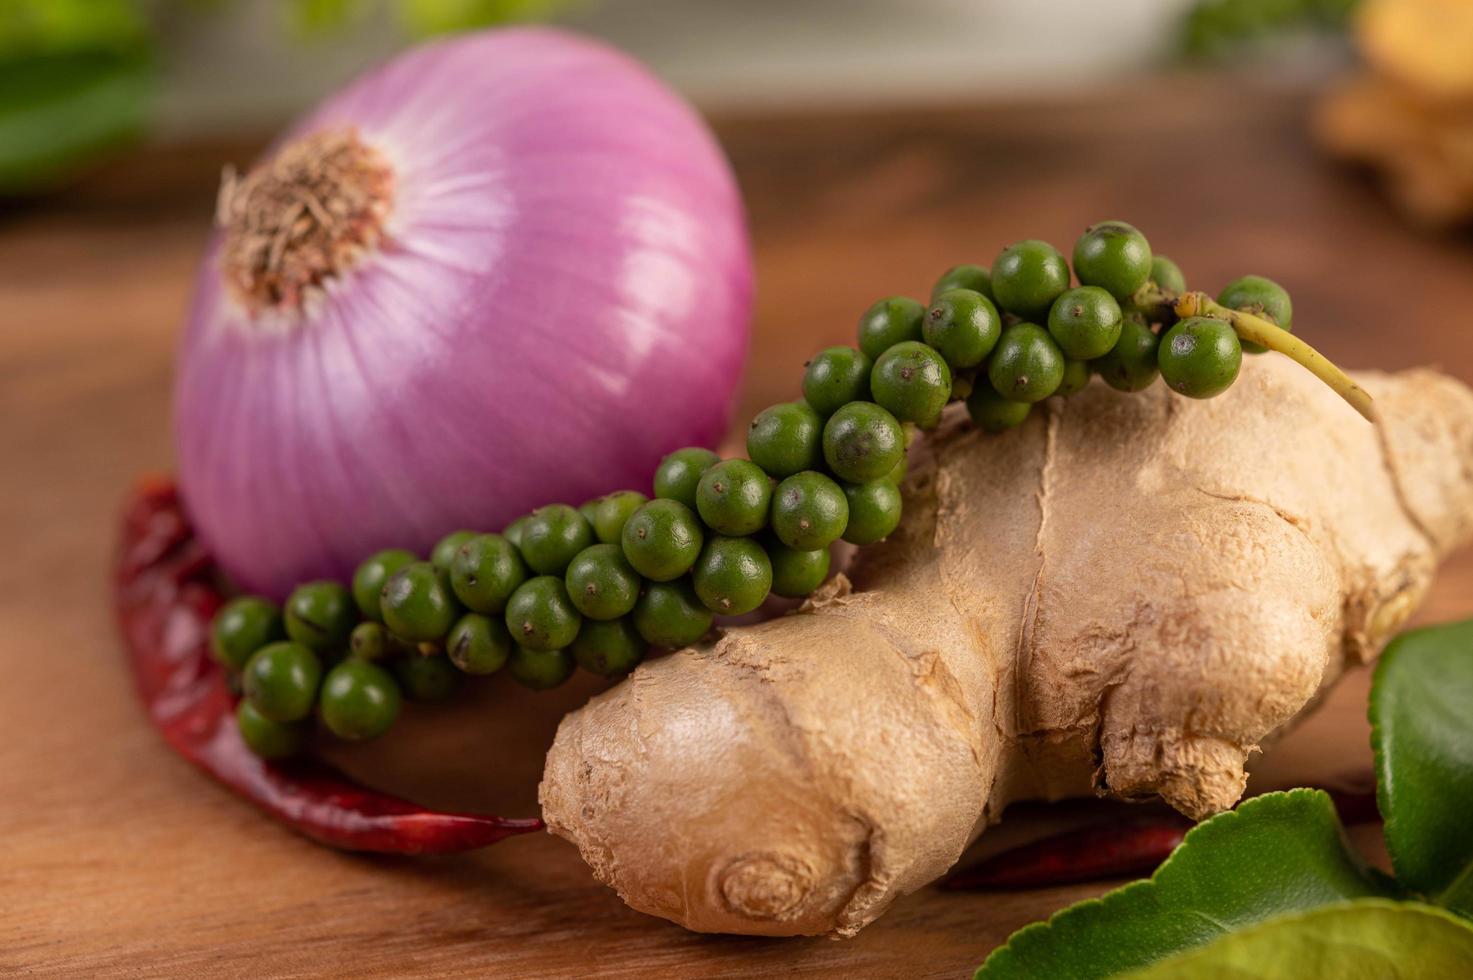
<box><xmin>1130</xmin><ymin>899</ymin><xmax>1473</xmax><ymax>980</ymax></box>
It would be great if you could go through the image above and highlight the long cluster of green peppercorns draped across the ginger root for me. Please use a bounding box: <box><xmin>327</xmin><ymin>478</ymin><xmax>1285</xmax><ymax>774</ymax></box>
<box><xmin>214</xmin><ymin>221</ymin><xmax>1292</xmax><ymax>757</ymax></box>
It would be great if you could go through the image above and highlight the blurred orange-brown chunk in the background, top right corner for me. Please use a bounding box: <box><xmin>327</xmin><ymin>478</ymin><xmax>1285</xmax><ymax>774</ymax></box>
<box><xmin>1315</xmin><ymin>0</ymin><xmax>1473</xmax><ymax>227</ymax></box>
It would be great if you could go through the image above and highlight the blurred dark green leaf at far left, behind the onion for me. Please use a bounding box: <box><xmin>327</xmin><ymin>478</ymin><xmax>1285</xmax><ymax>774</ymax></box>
<box><xmin>0</xmin><ymin>52</ymin><xmax>153</xmax><ymax>195</ymax></box>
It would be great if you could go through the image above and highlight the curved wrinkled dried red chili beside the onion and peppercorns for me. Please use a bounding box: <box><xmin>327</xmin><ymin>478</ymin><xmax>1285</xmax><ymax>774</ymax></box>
<box><xmin>113</xmin><ymin>479</ymin><xmax>542</xmax><ymax>855</ymax></box>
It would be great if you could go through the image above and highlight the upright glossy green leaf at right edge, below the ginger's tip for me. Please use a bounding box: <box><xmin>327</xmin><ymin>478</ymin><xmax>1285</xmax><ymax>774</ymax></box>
<box><xmin>1370</xmin><ymin>620</ymin><xmax>1473</xmax><ymax>917</ymax></box>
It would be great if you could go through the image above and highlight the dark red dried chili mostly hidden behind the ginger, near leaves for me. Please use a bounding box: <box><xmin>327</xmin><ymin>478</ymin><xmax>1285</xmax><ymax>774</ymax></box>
<box><xmin>941</xmin><ymin>790</ymin><xmax>1379</xmax><ymax>892</ymax></box>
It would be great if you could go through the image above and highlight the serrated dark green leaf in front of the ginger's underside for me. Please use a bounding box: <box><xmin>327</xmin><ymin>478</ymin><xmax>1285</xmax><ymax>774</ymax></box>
<box><xmin>977</xmin><ymin>790</ymin><xmax>1393</xmax><ymax>980</ymax></box>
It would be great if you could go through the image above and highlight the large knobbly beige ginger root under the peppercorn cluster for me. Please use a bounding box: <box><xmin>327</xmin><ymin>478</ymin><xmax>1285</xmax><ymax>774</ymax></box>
<box><xmin>541</xmin><ymin>357</ymin><xmax>1473</xmax><ymax>936</ymax></box>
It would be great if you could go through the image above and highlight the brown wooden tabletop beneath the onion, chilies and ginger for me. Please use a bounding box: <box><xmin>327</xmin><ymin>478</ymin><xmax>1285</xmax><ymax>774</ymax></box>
<box><xmin>0</xmin><ymin>80</ymin><xmax>1473</xmax><ymax>977</ymax></box>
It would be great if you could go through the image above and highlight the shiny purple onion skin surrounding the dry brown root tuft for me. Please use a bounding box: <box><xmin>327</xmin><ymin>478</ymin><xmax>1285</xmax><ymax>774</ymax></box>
<box><xmin>175</xmin><ymin>28</ymin><xmax>753</xmax><ymax>598</ymax></box>
